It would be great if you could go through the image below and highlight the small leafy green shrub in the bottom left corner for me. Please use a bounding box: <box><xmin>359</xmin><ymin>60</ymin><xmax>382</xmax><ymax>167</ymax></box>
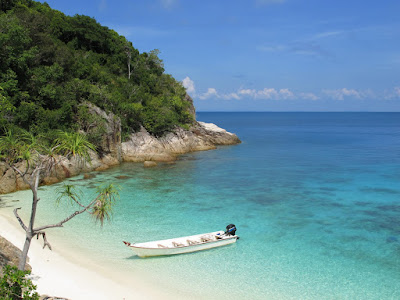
<box><xmin>0</xmin><ymin>265</ymin><xmax>39</xmax><ymax>300</ymax></box>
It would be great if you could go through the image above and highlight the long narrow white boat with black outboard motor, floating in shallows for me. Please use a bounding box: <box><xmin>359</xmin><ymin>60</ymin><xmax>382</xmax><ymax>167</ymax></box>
<box><xmin>124</xmin><ymin>225</ymin><xmax>239</xmax><ymax>257</ymax></box>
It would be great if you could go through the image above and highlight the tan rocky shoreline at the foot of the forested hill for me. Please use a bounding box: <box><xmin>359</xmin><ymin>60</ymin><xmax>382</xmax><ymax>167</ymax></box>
<box><xmin>0</xmin><ymin>102</ymin><xmax>240</xmax><ymax>194</ymax></box>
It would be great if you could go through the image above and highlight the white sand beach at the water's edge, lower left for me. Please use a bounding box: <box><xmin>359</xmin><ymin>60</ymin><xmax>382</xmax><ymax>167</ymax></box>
<box><xmin>0</xmin><ymin>210</ymin><xmax>173</xmax><ymax>300</ymax></box>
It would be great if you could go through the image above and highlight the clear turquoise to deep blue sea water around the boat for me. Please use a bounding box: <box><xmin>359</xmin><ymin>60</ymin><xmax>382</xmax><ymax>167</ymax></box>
<box><xmin>3</xmin><ymin>113</ymin><xmax>400</xmax><ymax>299</ymax></box>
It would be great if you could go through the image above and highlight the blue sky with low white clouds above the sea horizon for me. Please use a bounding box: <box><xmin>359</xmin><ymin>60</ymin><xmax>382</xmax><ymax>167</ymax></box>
<box><xmin>38</xmin><ymin>0</ymin><xmax>400</xmax><ymax>111</ymax></box>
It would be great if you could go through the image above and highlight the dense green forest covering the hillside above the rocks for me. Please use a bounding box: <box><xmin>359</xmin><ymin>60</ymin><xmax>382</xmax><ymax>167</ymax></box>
<box><xmin>0</xmin><ymin>0</ymin><xmax>193</xmax><ymax>141</ymax></box>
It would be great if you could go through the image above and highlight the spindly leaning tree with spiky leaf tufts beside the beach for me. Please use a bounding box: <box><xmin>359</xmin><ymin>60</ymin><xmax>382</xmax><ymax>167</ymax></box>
<box><xmin>0</xmin><ymin>130</ymin><xmax>119</xmax><ymax>270</ymax></box>
